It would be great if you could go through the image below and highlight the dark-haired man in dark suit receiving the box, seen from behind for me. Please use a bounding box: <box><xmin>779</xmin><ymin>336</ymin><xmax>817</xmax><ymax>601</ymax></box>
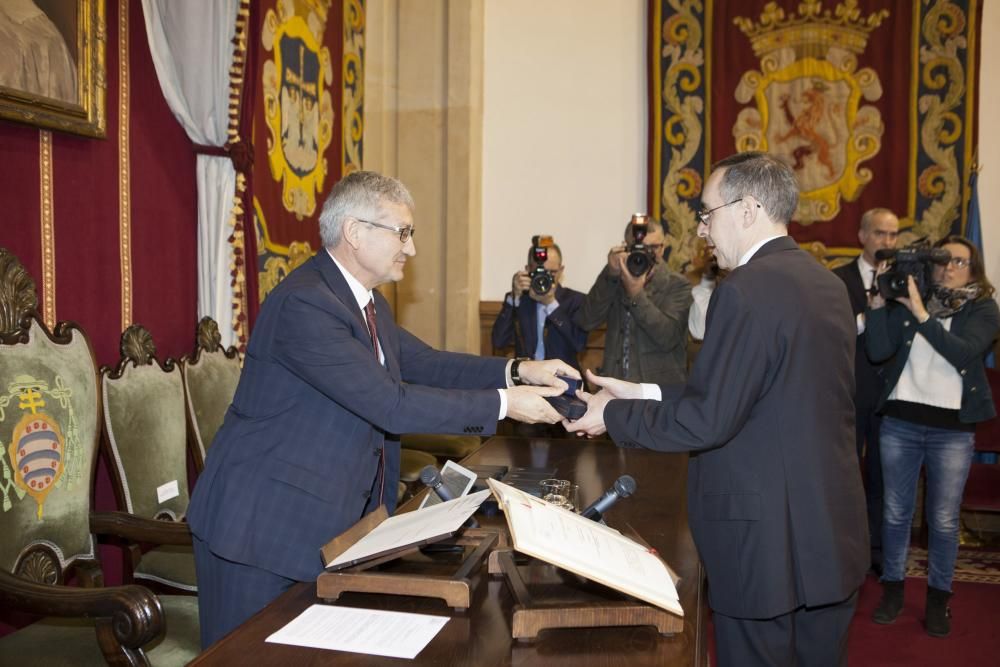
<box><xmin>566</xmin><ymin>152</ymin><xmax>868</xmax><ymax>667</ymax></box>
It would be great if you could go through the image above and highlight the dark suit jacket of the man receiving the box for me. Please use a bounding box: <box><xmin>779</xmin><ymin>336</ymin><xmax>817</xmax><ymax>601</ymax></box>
<box><xmin>604</xmin><ymin>236</ymin><xmax>869</xmax><ymax>619</ymax></box>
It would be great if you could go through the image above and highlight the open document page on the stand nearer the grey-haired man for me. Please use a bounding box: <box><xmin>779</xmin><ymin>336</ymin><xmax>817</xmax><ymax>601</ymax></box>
<box><xmin>326</xmin><ymin>490</ymin><xmax>490</xmax><ymax>570</ymax></box>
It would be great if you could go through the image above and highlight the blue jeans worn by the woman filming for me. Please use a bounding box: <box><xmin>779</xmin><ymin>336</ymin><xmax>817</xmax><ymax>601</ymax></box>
<box><xmin>880</xmin><ymin>417</ymin><xmax>974</xmax><ymax>591</ymax></box>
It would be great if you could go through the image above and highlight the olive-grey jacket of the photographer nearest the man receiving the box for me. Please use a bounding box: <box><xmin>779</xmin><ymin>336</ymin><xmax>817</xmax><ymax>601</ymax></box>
<box><xmin>576</xmin><ymin>264</ymin><xmax>691</xmax><ymax>383</ymax></box>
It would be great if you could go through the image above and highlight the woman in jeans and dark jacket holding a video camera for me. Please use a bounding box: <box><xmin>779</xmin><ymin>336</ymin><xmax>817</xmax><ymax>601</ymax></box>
<box><xmin>866</xmin><ymin>236</ymin><xmax>1000</xmax><ymax>637</ymax></box>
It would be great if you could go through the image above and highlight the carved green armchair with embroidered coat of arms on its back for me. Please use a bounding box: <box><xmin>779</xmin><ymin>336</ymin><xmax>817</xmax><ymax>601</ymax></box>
<box><xmin>0</xmin><ymin>248</ymin><xmax>200</xmax><ymax>666</ymax></box>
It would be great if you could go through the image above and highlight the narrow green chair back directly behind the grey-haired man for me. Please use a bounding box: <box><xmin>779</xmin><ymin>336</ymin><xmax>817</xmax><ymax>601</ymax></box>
<box><xmin>181</xmin><ymin>317</ymin><xmax>241</xmax><ymax>472</ymax></box>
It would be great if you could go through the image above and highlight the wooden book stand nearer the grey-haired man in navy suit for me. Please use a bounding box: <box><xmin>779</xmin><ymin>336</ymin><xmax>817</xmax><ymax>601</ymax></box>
<box><xmin>316</xmin><ymin>507</ymin><xmax>500</xmax><ymax>610</ymax></box>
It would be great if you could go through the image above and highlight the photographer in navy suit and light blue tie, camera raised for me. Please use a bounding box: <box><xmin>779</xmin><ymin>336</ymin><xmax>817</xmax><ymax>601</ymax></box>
<box><xmin>491</xmin><ymin>237</ymin><xmax>587</xmax><ymax>368</ymax></box>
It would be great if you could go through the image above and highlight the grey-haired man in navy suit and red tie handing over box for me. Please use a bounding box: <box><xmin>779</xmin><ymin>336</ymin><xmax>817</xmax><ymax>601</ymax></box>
<box><xmin>188</xmin><ymin>172</ymin><xmax>579</xmax><ymax>647</ymax></box>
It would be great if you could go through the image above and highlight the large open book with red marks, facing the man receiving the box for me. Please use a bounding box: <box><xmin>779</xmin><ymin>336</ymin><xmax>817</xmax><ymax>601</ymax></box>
<box><xmin>487</xmin><ymin>479</ymin><xmax>684</xmax><ymax>616</ymax></box>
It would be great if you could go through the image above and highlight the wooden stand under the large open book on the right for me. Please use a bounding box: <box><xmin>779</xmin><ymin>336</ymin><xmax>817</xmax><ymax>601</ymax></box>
<box><xmin>489</xmin><ymin>534</ymin><xmax>684</xmax><ymax>641</ymax></box>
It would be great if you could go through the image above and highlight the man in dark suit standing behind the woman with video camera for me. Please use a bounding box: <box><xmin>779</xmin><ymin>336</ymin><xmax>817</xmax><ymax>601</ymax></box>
<box><xmin>833</xmin><ymin>208</ymin><xmax>899</xmax><ymax>575</ymax></box>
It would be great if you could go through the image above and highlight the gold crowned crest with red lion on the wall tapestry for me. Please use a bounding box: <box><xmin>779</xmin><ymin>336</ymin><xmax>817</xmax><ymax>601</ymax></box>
<box><xmin>733</xmin><ymin>0</ymin><xmax>889</xmax><ymax>224</ymax></box>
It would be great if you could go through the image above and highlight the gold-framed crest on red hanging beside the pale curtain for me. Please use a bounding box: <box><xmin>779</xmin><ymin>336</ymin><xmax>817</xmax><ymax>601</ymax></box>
<box><xmin>261</xmin><ymin>0</ymin><xmax>334</xmax><ymax>220</ymax></box>
